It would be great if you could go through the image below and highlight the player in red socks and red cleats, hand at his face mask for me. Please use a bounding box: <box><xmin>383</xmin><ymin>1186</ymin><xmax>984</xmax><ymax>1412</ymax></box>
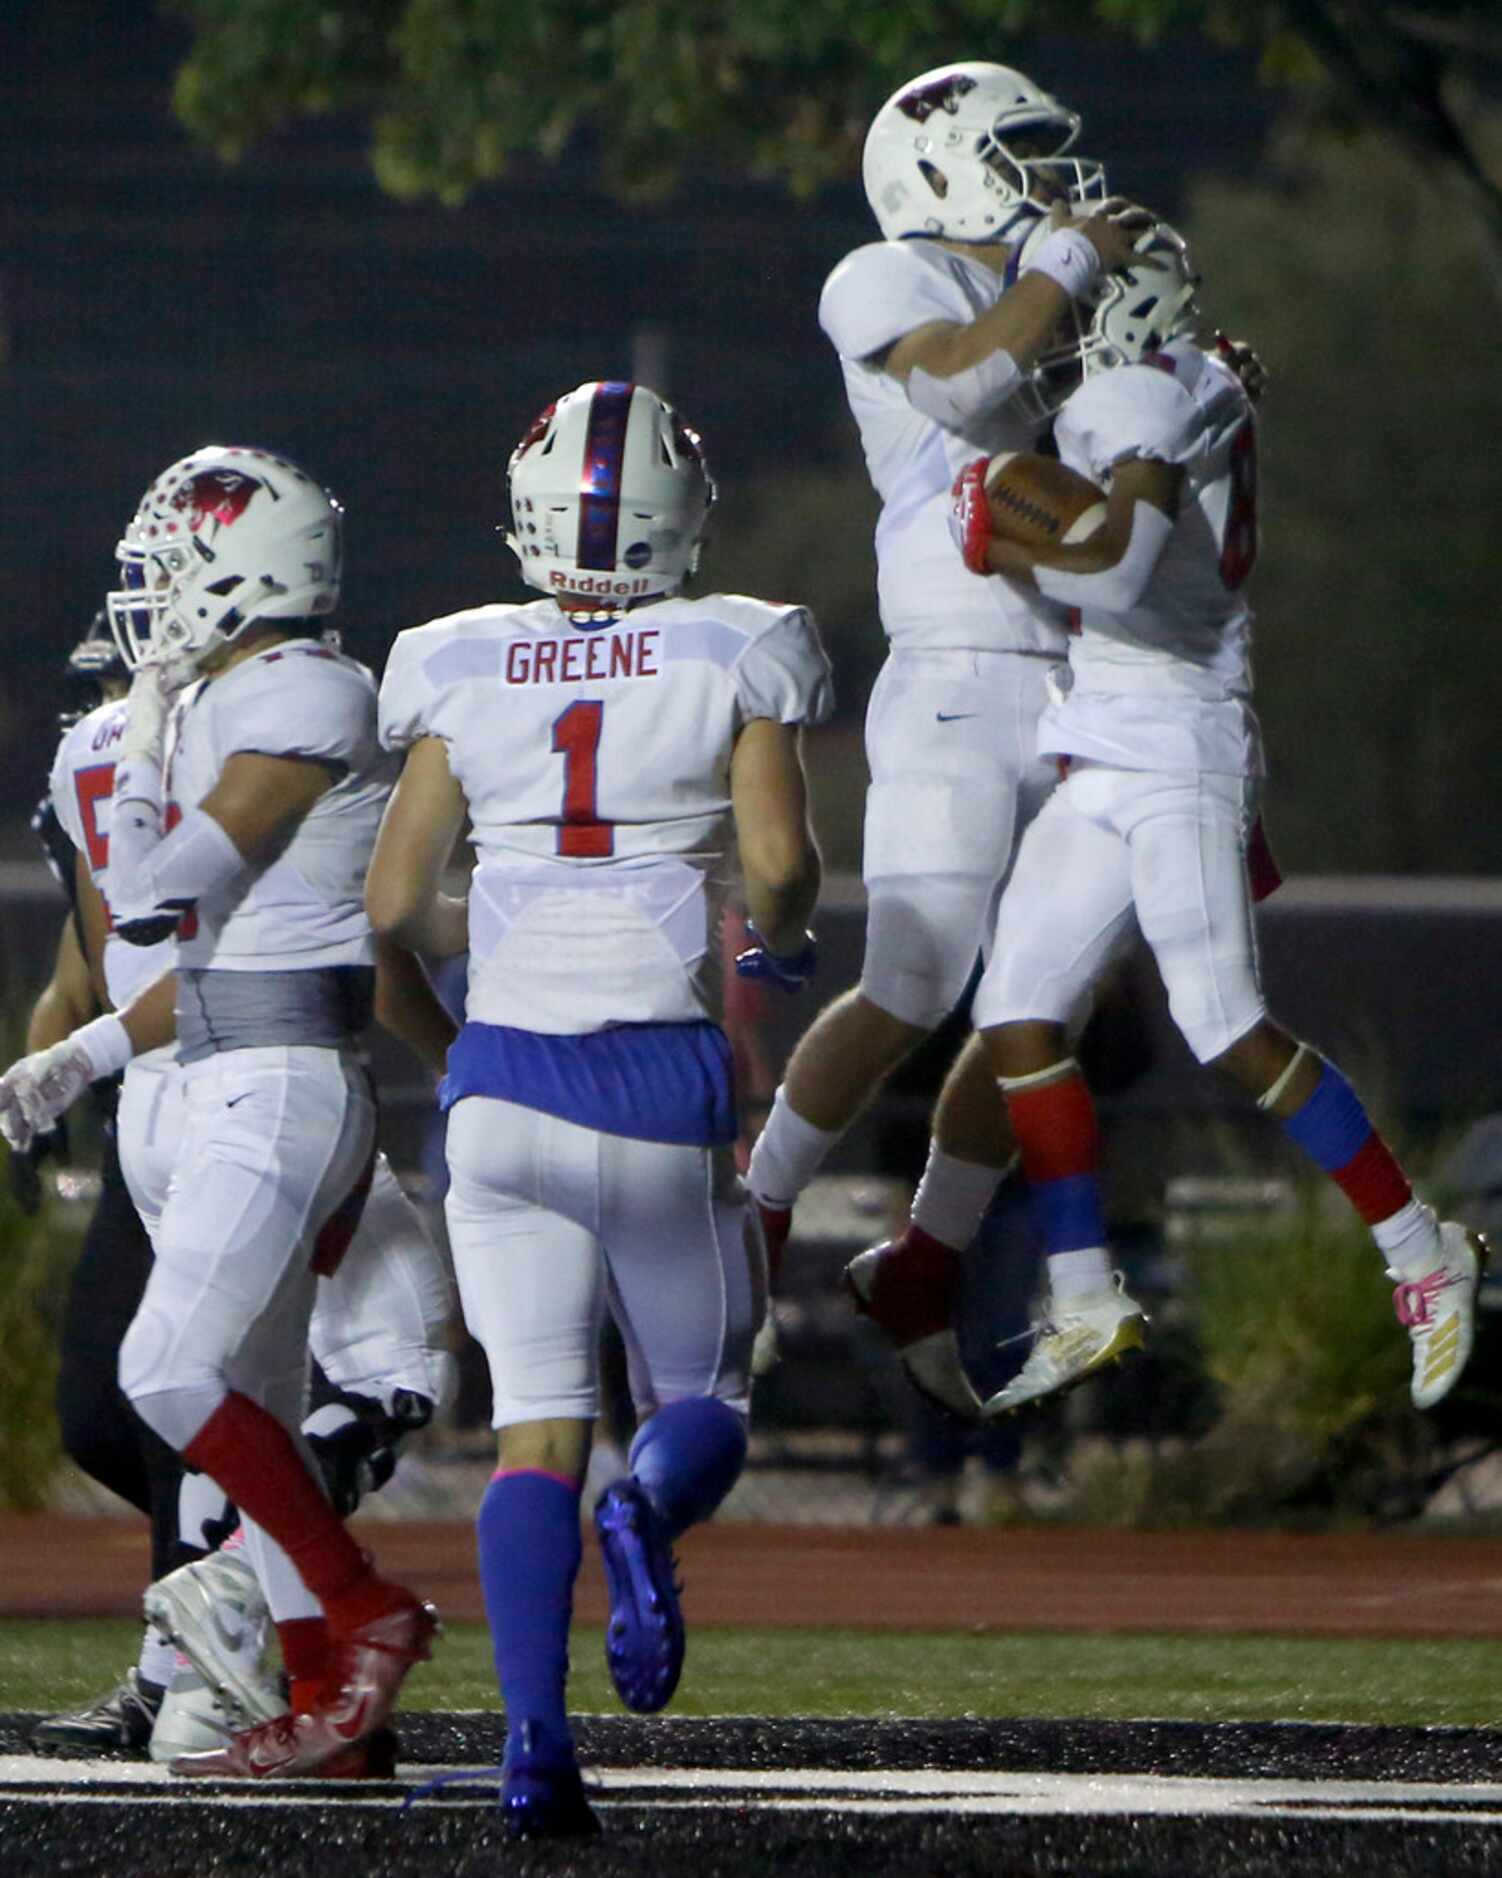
<box><xmin>0</xmin><ymin>445</ymin><xmax>436</xmax><ymax>1777</ymax></box>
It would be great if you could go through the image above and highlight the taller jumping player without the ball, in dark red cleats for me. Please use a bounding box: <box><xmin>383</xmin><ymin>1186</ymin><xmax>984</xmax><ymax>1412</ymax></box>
<box><xmin>749</xmin><ymin>62</ymin><xmax>1147</xmax><ymax>1414</ymax></box>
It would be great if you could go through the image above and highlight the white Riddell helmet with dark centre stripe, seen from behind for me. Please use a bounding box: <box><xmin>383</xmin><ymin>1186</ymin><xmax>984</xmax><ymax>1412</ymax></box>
<box><xmin>505</xmin><ymin>379</ymin><xmax>715</xmax><ymax>610</ymax></box>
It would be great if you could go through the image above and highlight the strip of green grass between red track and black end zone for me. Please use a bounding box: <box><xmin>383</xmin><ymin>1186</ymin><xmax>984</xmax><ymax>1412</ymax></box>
<box><xmin>0</xmin><ymin>1619</ymin><xmax>1502</xmax><ymax>1726</ymax></box>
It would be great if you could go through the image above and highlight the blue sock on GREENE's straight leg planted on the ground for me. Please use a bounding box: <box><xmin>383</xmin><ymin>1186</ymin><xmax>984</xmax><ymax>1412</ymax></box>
<box><xmin>475</xmin><ymin>1469</ymin><xmax>582</xmax><ymax>1752</ymax></box>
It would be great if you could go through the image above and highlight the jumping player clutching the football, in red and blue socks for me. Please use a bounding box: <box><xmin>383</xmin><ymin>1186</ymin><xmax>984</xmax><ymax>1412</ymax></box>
<box><xmin>954</xmin><ymin>225</ymin><xmax>1487</xmax><ymax>1412</ymax></box>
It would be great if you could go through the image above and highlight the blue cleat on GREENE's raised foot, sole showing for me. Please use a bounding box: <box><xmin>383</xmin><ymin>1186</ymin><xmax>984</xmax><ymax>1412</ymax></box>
<box><xmin>595</xmin><ymin>1476</ymin><xmax>683</xmax><ymax>1715</ymax></box>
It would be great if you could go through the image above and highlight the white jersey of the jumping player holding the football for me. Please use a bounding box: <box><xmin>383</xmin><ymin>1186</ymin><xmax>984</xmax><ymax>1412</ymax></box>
<box><xmin>1038</xmin><ymin>340</ymin><xmax>1262</xmax><ymax>776</ymax></box>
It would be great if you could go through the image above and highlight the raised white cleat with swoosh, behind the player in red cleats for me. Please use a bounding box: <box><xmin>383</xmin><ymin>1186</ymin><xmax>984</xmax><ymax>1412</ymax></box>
<box><xmin>141</xmin><ymin>1551</ymin><xmax>287</xmax><ymax>1720</ymax></box>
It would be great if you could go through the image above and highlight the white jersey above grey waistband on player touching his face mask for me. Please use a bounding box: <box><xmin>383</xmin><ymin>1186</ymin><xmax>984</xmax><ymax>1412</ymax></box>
<box><xmin>165</xmin><ymin>639</ymin><xmax>394</xmax><ymax>971</ymax></box>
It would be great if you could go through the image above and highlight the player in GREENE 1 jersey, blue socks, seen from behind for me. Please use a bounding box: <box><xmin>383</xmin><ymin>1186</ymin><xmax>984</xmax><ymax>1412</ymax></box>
<box><xmin>366</xmin><ymin>381</ymin><xmax>830</xmax><ymax>1837</ymax></box>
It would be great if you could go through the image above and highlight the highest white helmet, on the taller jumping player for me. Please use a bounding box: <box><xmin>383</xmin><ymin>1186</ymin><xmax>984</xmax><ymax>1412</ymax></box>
<box><xmin>862</xmin><ymin>60</ymin><xmax>1106</xmax><ymax>240</ymax></box>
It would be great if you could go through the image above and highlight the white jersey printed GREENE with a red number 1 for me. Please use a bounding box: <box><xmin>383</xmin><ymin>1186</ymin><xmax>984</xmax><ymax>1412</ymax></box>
<box><xmin>381</xmin><ymin>593</ymin><xmax>832</xmax><ymax>1035</ymax></box>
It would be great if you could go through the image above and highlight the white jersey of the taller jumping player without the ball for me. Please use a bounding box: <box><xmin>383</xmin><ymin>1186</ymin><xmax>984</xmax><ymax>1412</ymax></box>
<box><xmin>819</xmin><ymin>240</ymin><xmax>1066</xmax><ymax>654</ymax></box>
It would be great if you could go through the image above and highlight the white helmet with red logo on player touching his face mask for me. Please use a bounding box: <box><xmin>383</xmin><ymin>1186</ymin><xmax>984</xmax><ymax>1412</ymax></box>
<box><xmin>107</xmin><ymin>443</ymin><xmax>344</xmax><ymax>680</ymax></box>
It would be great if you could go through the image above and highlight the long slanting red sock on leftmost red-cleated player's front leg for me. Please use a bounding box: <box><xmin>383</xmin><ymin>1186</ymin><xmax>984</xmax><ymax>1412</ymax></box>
<box><xmin>182</xmin><ymin>1390</ymin><xmax>372</xmax><ymax>1621</ymax></box>
